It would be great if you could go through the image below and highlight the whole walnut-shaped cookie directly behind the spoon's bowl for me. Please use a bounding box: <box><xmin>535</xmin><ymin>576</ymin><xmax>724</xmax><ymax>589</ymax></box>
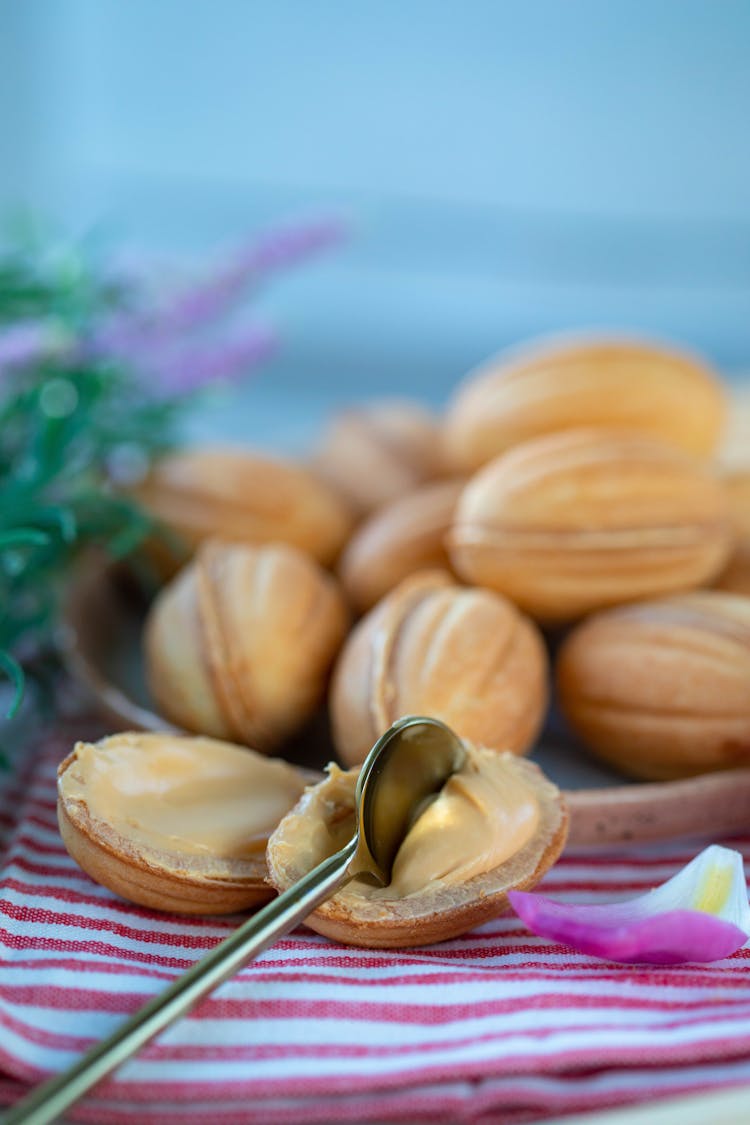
<box><xmin>329</xmin><ymin>572</ymin><xmax>548</xmax><ymax>765</ymax></box>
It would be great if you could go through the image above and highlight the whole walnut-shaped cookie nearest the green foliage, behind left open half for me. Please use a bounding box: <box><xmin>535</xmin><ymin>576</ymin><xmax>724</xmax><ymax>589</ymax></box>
<box><xmin>145</xmin><ymin>541</ymin><xmax>349</xmax><ymax>752</ymax></box>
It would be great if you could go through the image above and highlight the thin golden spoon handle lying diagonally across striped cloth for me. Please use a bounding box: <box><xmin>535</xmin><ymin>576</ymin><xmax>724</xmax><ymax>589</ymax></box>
<box><xmin>2</xmin><ymin>836</ymin><xmax>359</xmax><ymax>1125</ymax></box>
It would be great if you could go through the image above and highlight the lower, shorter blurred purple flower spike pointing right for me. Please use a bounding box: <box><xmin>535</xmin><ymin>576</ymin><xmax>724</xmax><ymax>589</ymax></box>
<box><xmin>141</xmin><ymin>325</ymin><xmax>277</xmax><ymax>395</ymax></box>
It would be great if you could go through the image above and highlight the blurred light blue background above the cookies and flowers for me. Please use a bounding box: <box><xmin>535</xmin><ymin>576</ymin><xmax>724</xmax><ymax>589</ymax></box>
<box><xmin>0</xmin><ymin>0</ymin><xmax>750</xmax><ymax>444</ymax></box>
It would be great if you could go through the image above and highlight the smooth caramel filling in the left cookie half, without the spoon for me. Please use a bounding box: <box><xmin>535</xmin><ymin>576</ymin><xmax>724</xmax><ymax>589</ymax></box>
<box><xmin>58</xmin><ymin>734</ymin><xmax>305</xmax><ymax>860</ymax></box>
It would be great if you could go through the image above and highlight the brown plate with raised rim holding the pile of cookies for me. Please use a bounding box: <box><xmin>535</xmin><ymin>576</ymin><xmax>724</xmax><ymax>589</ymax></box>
<box><xmin>62</xmin><ymin>561</ymin><xmax>750</xmax><ymax>847</ymax></box>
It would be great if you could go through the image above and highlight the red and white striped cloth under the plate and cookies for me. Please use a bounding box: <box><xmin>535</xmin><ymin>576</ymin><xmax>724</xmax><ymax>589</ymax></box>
<box><xmin>0</xmin><ymin>720</ymin><xmax>750</xmax><ymax>1125</ymax></box>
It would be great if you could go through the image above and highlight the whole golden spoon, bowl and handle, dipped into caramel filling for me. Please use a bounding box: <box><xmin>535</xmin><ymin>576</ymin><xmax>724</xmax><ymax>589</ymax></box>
<box><xmin>3</xmin><ymin>716</ymin><xmax>464</xmax><ymax>1125</ymax></box>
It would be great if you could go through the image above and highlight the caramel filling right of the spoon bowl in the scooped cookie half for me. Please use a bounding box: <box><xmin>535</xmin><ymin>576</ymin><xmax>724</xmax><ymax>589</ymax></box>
<box><xmin>383</xmin><ymin>755</ymin><xmax>540</xmax><ymax>898</ymax></box>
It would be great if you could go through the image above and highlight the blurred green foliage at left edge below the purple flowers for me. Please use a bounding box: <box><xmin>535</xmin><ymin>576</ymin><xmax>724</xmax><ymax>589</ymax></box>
<box><xmin>0</xmin><ymin>342</ymin><xmax>183</xmax><ymax>713</ymax></box>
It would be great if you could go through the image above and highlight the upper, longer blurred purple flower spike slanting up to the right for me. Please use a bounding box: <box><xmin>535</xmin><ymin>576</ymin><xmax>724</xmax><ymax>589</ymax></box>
<box><xmin>92</xmin><ymin>219</ymin><xmax>345</xmax><ymax>358</ymax></box>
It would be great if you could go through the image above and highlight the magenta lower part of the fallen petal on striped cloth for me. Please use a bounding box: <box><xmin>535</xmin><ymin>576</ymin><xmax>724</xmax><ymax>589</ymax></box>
<box><xmin>508</xmin><ymin>891</ymin><xmax>748</xmax><ymax>965</ymax></box>
